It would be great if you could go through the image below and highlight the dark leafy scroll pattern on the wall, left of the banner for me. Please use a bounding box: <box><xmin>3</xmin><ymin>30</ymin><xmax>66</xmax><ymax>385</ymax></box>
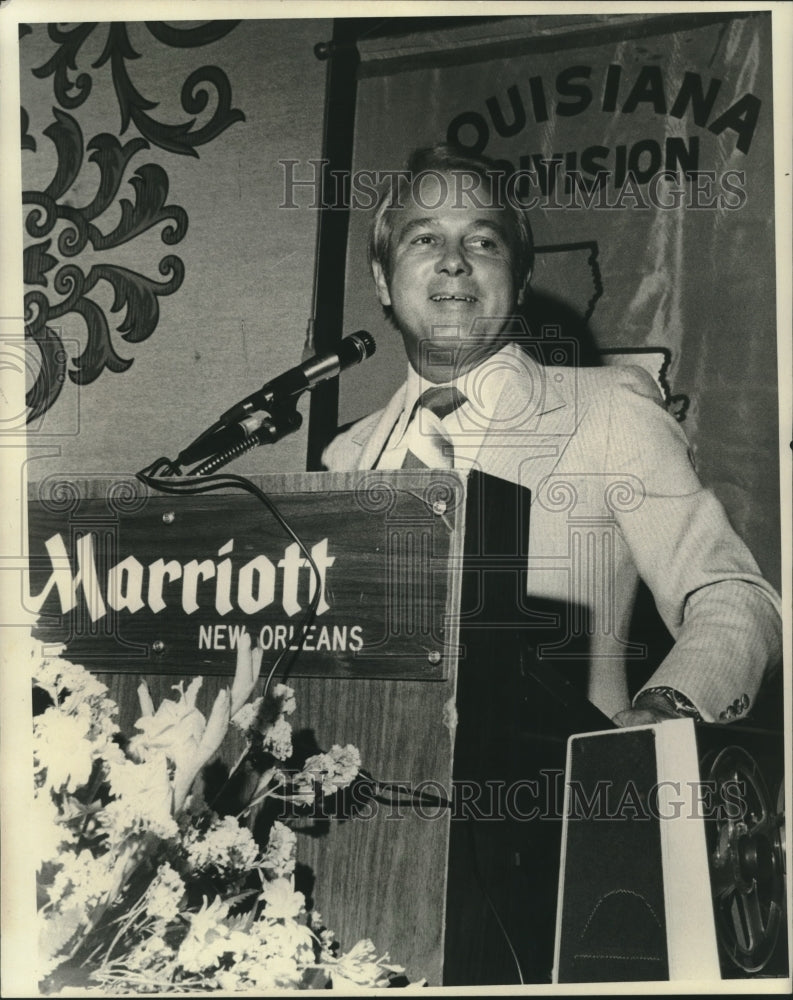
<box><xmin>20</xmin><ymin>21</ymin><xmax>245</xmax><ymax>421</ymax></box>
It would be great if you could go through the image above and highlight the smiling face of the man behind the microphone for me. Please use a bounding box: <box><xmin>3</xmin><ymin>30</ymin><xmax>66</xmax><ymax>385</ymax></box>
<box><xmin>373</xmin><ymin>174</ymin><xmax>522</xmax><ymax>382</ymax></box>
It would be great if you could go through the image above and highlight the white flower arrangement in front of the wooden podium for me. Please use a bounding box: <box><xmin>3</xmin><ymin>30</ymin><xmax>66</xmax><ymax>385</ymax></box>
<box><xmin>31</xmin><ymin>635</ymin><xmax>404</xmax><ymax>994</ymax></box>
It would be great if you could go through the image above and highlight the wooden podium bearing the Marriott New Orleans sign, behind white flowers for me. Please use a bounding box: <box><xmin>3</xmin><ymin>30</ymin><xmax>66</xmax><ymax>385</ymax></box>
<box><xmin>28</xmin><ymin>470</ymin><xmax>603</xmax><ymax>985</ymax></box>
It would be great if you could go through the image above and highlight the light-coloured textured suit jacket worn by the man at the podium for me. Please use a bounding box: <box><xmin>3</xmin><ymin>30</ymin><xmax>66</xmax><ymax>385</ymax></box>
<box><xmin>323</xmin><ymin>352</ymin><xmax>782</xmax><ymax>722</ymax></box>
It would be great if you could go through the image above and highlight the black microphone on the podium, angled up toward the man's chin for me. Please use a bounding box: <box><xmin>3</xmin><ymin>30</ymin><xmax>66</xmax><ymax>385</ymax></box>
<box><xmin>177</xmin><ymin>330</ymin><xmax>376</xmax><ymax>465</ymax></box>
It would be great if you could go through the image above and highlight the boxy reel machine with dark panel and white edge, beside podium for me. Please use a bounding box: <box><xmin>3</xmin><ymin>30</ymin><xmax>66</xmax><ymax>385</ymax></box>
<box><xmin>553</xmin><ymin>719</ymin><xmax>788</xmax><ymax>983</ymax></box>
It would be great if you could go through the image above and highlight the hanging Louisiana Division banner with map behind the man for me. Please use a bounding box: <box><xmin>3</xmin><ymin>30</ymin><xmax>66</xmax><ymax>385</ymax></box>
<box><xmin>339</xmin><ymin>13</ymin><xmax>780</xmax><ymax>586</ymax></box>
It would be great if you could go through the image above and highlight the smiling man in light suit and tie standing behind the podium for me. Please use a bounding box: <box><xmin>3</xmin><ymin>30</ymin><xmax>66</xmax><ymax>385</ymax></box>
<box><xmin>323</xmin><ymin>146</ymin><xmax>781</xmax><ymax>725</ymax></box>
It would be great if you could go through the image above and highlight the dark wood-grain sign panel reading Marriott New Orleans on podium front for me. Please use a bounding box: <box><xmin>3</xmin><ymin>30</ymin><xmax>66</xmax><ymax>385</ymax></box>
<box><xmin>23</xmin><ymin>472</ymin><xmax>464</xmax><ymax>680</ymax></box>
